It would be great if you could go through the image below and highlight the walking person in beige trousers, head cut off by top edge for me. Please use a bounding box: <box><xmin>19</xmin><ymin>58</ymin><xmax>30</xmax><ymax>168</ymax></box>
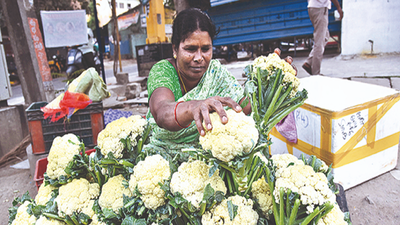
<box><xmin>303</xmin><ymin>0</ymin><xmax>343</xmax><ymax>75</ymax></box>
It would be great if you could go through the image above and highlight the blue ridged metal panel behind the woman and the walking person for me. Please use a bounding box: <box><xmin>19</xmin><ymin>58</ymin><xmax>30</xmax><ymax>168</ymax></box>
<box><xmin>207</xmin><ymin>0</ymin><xmax>342</xmax><ymax>54</ymax></box>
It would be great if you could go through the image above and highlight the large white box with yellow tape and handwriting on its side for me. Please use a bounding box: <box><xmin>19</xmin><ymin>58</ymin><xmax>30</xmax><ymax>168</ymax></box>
<box><xmin>270</xmin><ymin>76</ymin><xmax>400</xmax><ymax>190</ymax></box>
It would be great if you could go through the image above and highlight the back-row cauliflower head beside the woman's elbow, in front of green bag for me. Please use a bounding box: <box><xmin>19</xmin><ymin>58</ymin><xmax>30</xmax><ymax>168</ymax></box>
<box><xmin>97</xmin><ymin>115</ymin><xmax>147</xmax><ymax>159</ymax></box>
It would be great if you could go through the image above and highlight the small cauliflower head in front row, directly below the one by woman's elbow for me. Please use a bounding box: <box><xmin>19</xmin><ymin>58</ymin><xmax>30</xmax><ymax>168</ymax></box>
<box><xmin>99</xmin><ymin>175</ymin><xmax>132</xmax><ymax>213</ymax></box>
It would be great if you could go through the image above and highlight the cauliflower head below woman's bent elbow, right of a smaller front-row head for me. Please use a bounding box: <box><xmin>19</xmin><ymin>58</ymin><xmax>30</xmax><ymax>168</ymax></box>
<box><xmin>129</xmin><ymin>155</ymin><xmax>171</xmax><ymax>209</ymax></box>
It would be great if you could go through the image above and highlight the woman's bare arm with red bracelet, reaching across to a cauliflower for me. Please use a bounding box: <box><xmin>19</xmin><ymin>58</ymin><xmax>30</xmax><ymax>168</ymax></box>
<box><xmin>149</xmin><ymin>87</ymin><xmax>242</xmax><ymax>136</ymax></box>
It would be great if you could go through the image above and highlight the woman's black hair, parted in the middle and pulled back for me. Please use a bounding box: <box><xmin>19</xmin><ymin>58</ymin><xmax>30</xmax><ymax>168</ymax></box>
<box><xmin>171</xmin><ymin>8</ymin><xmax>217</xmax><ymax>48</ymax></box>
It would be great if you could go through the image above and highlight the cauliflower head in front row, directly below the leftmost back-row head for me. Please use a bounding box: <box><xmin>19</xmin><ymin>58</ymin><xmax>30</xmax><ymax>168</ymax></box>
<box><xmin>55</xmin><ymin>178</ymin><xmax>100</xmax><ymax>218</ymax></box>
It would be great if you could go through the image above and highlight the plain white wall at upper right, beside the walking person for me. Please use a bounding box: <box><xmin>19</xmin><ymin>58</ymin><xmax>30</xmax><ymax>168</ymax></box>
<box><xmin>342</xmin><ymin>0</ymin><xmax>400</xmax><ymax>55</ymax></box>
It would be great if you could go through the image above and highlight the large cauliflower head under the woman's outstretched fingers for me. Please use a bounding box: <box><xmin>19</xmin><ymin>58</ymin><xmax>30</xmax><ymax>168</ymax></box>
<box><xmin>200</xmin><ymin>109</ymin><xmax>258</xmax><ymax>162</ymax></box>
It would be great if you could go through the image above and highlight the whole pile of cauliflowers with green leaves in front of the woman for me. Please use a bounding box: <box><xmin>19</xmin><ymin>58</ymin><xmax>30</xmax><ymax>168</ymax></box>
<box><xmin>9</xmin><ymin>110</ymin><xmax>347</xmax><ymax>225</ymax></box>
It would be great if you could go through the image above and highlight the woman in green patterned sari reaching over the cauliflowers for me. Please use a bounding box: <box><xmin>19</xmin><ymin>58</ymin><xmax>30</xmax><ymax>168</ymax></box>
<box><xmin>147</xmin><ymin>9</ymin><xmax>292</xmax><ymax>150</ymax></box>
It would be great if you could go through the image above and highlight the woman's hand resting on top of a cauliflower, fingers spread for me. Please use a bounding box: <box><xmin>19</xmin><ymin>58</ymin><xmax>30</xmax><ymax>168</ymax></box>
<box><xmin>190</xmin><ymin>96</ymin><xmax>242</xmax><ymax>136</ymax></box>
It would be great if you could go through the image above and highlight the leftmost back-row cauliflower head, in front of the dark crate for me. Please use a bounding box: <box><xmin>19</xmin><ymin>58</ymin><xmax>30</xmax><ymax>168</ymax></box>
<box><xmin>46</xmin><ymin>133</ymin><xmax>80</xmax><ymax>179</ymax></box>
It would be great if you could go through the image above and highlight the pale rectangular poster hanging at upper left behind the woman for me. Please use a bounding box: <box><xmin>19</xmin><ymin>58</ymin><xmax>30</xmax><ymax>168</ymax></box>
<box><xmin>40</xmin><ymin>10</ymin><xmax>88</xmax><ymax>48</ymax></box>
